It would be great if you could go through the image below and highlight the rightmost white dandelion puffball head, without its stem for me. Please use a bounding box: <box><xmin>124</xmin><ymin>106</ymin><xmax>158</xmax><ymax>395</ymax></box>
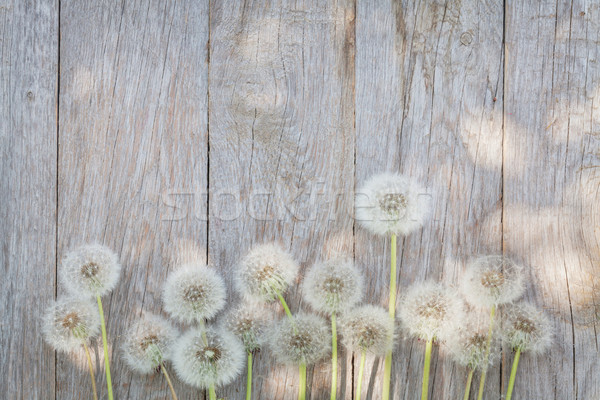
<box><xmin>503</xmin><ymin>302</ymin><xmax>554</xmax><ymax>354</ymax></box>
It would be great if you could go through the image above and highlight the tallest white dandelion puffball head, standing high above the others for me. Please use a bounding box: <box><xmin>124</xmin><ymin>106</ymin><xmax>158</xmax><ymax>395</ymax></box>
<box><xmin>355</xmin><ymin>172</ymin><xmax>431</xmax><ymax>235</ymax></box>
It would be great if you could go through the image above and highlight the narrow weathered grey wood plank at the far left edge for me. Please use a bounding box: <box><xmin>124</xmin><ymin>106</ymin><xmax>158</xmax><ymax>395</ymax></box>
<box><xmin>0</xmin><ymin>0</ymin><xmax>58</xmax><ymax>399</ymax></box>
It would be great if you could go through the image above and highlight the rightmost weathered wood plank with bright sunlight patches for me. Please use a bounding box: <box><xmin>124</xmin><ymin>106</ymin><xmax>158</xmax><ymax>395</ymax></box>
<box><xmin>503</xmin><ymin>1</ymin><xmax>600</xmax><ymax>399</ymax></box>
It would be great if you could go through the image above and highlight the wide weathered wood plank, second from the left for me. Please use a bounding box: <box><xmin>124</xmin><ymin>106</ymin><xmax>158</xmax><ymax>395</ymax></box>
<box><xmin>57</xmin><ymin>0</ymin><xmax>208</xmax><ymax>399</ymax></box>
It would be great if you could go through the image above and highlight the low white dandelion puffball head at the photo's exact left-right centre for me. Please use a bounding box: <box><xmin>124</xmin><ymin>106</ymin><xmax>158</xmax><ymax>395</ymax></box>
<box><xmin>269</xmin><ymin>313</ymin><xmax>331</xmax><ymax>365</ymax></box>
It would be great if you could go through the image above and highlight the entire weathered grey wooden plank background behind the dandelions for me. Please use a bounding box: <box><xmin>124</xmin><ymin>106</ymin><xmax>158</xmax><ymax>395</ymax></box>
<box><xmin>0</xmin><ymin>0</ymin><xmax>600</xmax><ymax>400</ymax></box>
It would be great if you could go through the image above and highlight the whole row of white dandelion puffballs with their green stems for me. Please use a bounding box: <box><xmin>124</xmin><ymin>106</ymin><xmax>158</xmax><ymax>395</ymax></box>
<box><xmin>44</xmin><ymin>173</ymin><xmax>552</xmax><ymax>400</ymax></box>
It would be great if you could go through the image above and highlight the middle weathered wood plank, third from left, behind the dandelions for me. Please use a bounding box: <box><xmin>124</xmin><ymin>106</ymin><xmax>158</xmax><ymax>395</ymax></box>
<box><xmin>209</xmin><ymin>0</ymin><xmax>354</xmax><ymax>399</ymax></box>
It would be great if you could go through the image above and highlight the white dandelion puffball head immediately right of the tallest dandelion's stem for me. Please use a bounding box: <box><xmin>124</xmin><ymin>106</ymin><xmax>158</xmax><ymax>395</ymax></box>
<box><xmin>399</xmin><ymin>282</ymin><xmax>464</xmax><ymax>342</ymax></box>
